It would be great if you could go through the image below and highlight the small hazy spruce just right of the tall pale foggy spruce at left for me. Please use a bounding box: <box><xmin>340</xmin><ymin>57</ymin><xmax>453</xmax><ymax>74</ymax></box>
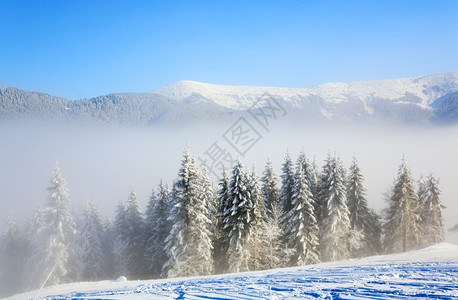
<box><xmin>73</xmin><ymin>203</ymin><xmax>107</xmax><ymax>281</ymax></box>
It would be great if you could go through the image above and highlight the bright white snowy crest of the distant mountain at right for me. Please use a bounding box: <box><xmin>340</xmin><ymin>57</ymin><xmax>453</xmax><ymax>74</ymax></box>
<box><xmin>153</xmin><ymin>72</ymin><xmax>458</xmax><ymax>113</ymax></box>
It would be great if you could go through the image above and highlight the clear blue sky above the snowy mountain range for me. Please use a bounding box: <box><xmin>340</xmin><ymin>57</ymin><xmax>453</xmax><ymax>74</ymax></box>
<box><xmin>0</xmin><ymin>0</ymin><xmax>458</xmax><ymax>99</ymax></box>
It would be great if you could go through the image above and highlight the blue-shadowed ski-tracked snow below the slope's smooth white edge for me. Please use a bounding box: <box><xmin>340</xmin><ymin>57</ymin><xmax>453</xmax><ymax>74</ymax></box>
<box><xmin>36</xmin><ymin>261</ymin><xmax>458</xmax><ymax>299</ymax></box>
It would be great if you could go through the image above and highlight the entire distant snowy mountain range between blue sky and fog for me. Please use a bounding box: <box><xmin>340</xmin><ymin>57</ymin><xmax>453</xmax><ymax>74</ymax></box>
<box><xmin>0</xmin><ymin>72</ymin><xmax>458</xmax><ymax>126</ymax></box>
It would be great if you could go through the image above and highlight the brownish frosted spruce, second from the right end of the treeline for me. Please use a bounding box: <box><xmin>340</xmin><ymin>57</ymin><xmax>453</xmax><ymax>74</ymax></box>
<box><xmin>384</xmin><ymin>159</ymin><xmax>421</xmax><ymax>253</ymax></box>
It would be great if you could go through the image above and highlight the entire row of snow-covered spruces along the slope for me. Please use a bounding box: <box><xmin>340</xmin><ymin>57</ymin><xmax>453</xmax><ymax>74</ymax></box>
<box><xmin>0</xmin><ymin>150</ymin><xmax>444</xmax><ymax>296</ymax></box>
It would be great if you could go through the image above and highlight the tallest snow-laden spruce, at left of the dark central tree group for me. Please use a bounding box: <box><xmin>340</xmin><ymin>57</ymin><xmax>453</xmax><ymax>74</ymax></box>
<box><xmin>163</xmin><ymin>149</ymin><xmax>213</xmax><ymax>277</ymax></box>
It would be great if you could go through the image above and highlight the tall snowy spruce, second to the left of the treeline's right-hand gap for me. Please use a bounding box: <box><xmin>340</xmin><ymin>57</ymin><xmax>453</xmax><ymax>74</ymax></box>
<box><xmin>319</xmin><ymin>156</ymin><xmax>350</xmax><ymax>261</ymax></box>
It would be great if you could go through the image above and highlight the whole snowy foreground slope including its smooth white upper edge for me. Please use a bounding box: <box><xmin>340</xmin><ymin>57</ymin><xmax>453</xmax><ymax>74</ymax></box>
<box><xmin>10</xmin><ymin>243</ymin><xmax>458</xmax><ymax>299</ymax></box>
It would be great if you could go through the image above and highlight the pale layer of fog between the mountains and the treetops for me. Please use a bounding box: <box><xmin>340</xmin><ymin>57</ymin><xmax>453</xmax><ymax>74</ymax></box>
<box><xmin>0</xmin><ymin>119</ymin><xmax>458</xmax><ymax>243</ymax></box>
